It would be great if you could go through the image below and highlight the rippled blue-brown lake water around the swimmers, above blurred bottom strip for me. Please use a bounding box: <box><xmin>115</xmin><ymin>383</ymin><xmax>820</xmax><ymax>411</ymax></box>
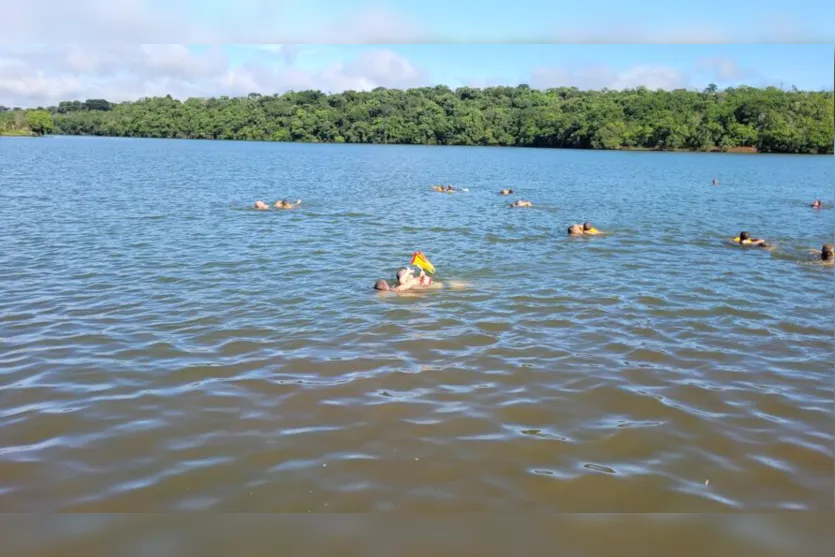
<box><xmin>0</xmin><ymin>137</ymin><xmax>835</xmax><ymax>524</ymax></box>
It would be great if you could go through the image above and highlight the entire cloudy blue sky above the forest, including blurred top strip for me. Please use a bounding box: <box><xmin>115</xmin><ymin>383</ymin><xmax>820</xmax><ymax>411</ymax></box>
<box><xmin>0</xmin><ymin>0</ymin><xmax>835</xmax><ymax>107</ymax></box>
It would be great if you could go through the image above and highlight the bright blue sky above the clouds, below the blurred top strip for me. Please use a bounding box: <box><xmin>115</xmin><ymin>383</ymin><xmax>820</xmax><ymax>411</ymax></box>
<box><xmin>227</xmin><ymin>44</ymin><xmax>835</xmax><ymax>90</ymax></box>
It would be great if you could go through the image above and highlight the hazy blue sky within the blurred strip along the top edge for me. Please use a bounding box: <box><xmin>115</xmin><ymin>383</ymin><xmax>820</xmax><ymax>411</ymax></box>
<box><xmin>180</xmin><ymin>0</ymin><xmax>835</xmax><ymax>43</ymax></box>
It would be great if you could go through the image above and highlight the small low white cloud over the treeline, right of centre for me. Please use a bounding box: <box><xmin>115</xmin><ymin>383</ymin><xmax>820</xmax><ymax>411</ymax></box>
<box><xmin>530</xmin><ymin>65</ymin><xmax>688</xmax><ymax>90</ymax></box>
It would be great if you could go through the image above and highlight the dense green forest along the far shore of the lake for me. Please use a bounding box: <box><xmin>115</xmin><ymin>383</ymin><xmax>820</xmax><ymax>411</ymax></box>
<box><xmin>0</xmin><ymin>85</ymin><xmax>835</xmax><ymax>154</ymax></box>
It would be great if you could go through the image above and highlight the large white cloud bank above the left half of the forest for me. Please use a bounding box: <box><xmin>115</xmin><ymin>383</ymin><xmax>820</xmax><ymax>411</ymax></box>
<box><xmin>0</xmin><ymin>44</ymin><xmax>428</xmax><ymax>107</ymax></box>
